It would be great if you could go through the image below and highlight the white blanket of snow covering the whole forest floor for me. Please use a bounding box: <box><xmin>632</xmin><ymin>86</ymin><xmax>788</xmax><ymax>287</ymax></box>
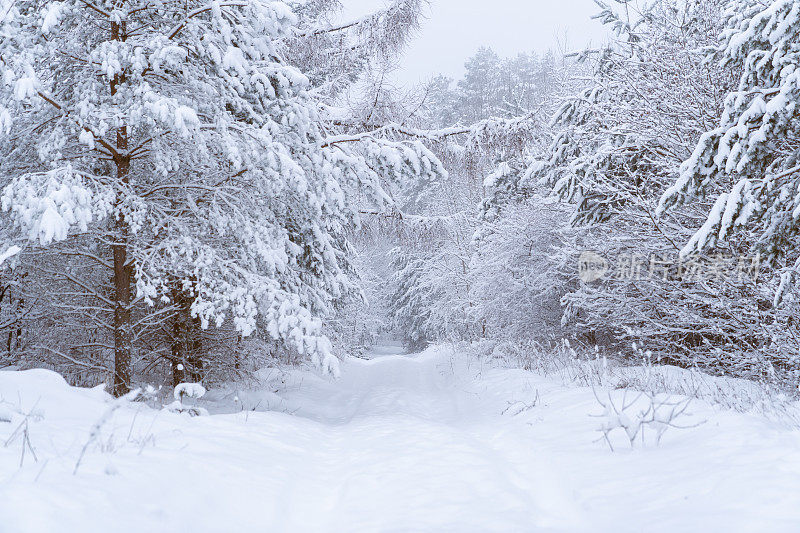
<box><xmin>0</xmin><ymin>348</ymin><xmax>800</xmax><ymax>533</ymax></box>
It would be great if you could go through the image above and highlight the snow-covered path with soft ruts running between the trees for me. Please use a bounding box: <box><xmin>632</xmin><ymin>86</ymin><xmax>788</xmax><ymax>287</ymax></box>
<box><xmin>266</xmin><ymin>346</ymin><xmax>581</xmax><ymax>531</ymax></box>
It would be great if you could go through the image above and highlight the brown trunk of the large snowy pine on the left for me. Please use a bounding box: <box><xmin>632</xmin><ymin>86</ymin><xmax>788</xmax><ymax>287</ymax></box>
<box><xmin>111</xmin><ymin>22</ymin><xmax>133</xmax><ymax>397</ymax></box>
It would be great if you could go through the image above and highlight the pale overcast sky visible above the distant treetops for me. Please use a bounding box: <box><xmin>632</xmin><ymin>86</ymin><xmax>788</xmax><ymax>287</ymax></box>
<box><xmin>343</xmin><ymin>0</ymin><xmax>603</xmax><ymax>84</ymax></box>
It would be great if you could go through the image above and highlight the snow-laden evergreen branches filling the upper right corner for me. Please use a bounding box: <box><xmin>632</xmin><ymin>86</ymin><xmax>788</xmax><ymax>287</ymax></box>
<box><xmin>658</xmin><ymin>0</ymin><xmax>800</xmax><ymax>274</ymax></box>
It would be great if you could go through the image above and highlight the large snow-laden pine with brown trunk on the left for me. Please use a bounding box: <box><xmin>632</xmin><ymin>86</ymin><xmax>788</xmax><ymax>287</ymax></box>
<box><xmin>0</xmin><ymin>0</ymin><xmax>441</xmax><ymax>395</ymax></box>
